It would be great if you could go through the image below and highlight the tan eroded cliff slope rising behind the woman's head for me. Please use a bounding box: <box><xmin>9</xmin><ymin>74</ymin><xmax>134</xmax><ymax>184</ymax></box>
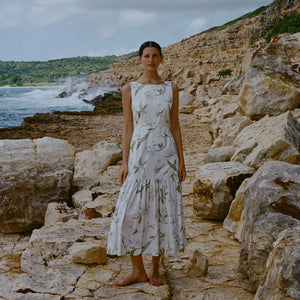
<box><xmin>90</xmin><ymin>0</ymin><xmax>300</xmax><ymax>97</ymax></box>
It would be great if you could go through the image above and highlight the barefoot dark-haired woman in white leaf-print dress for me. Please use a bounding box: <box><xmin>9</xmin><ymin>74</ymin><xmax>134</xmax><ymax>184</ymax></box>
<box><xmin>107</xmin><ymin>41</ymin><xmax>186</xmax><ymax>286</ymax></box>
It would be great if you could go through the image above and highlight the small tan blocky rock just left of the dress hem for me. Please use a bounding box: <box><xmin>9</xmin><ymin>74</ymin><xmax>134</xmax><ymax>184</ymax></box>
<box><xmin>69</xmin><ymin>241</ymin><xmax>107</xmax><ymax>265</ymax></box>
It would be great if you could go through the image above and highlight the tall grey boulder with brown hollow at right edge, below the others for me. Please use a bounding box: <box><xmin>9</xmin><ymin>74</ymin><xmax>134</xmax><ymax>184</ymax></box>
<box><xmin>239</xmin><ymin>161</ymin><xmax>300</xmax><ymax>291</ymax></box>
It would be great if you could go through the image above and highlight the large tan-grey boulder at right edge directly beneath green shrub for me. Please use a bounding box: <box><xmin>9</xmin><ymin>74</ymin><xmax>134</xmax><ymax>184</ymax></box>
<box><xmin>239</xmin><ymin>33</ymin><xmax>300</xmax><ymax>120</ymax></box>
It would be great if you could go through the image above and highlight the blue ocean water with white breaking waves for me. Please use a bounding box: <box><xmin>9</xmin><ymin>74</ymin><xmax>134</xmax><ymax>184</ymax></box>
<box><xmin>0</xmin><ymin>81</ymin><xmax>105</xmax><ymax>128</ymax></box>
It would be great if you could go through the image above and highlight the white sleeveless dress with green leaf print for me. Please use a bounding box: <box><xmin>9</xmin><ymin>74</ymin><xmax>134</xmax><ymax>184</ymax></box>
<box><xmin>107</xmin><ymin>81</ymin><xmax>186</xmax><ymax>256</ymax></box>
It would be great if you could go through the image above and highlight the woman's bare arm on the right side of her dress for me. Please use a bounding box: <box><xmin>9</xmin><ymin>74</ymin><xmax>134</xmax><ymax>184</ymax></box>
<box><xmin>170</xmin><ymin>82</ymin><xmax>186</xmax><ymax>182</ymax></box>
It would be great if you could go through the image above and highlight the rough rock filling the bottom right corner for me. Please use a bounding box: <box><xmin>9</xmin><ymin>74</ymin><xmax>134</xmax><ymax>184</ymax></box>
<box><xmin>254</xmin><ymin>227</ymin><xmax>300</xmax><ymax>300</ymax></box>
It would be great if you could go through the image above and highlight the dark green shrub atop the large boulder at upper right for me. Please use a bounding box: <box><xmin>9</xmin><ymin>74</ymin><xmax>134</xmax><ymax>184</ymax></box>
<box><xmin>266</xmin><ymin>14</ymin><xmax>300</xmax><ymax>43</ymax></box>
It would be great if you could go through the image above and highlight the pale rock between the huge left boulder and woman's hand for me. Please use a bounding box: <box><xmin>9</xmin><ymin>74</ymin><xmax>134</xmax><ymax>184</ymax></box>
<box><xmin>73</xmin><ymin>141</ymin><xmax>122</xmax><ymax>187</ymax></box>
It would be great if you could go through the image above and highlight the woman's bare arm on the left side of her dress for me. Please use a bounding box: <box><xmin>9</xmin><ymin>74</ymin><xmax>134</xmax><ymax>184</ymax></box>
<box><xmin>119</xmin><ymin>83</ymin><xmax>133</xmax><ymax>185</ymax></box>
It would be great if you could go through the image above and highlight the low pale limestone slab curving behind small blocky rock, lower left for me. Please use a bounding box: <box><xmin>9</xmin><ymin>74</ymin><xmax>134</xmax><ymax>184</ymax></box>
<box><xmin>21</xmin><ymin>218</ymin><xmax>110</xmax><ymax>275</ymax></box>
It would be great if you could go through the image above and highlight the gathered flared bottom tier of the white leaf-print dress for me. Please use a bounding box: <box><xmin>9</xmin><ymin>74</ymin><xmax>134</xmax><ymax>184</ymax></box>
<box><xmin>107</xmin><ymin>176</ymin><xmax>187</xmax><ymax>256</ymax></box>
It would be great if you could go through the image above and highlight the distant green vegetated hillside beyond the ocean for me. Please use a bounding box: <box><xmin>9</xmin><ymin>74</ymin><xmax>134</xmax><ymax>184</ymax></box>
<box><xmin>0</xmin><ymin>53</ymin><xmax>135</xmax><ymax>86</ymax></box>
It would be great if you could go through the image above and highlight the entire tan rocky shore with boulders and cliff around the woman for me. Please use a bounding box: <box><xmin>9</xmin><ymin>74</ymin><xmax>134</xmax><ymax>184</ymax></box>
<box><xmin>0</xmin><ymin>0</ymin><xmax>300</xmax><ymax>300</ymax></box>
